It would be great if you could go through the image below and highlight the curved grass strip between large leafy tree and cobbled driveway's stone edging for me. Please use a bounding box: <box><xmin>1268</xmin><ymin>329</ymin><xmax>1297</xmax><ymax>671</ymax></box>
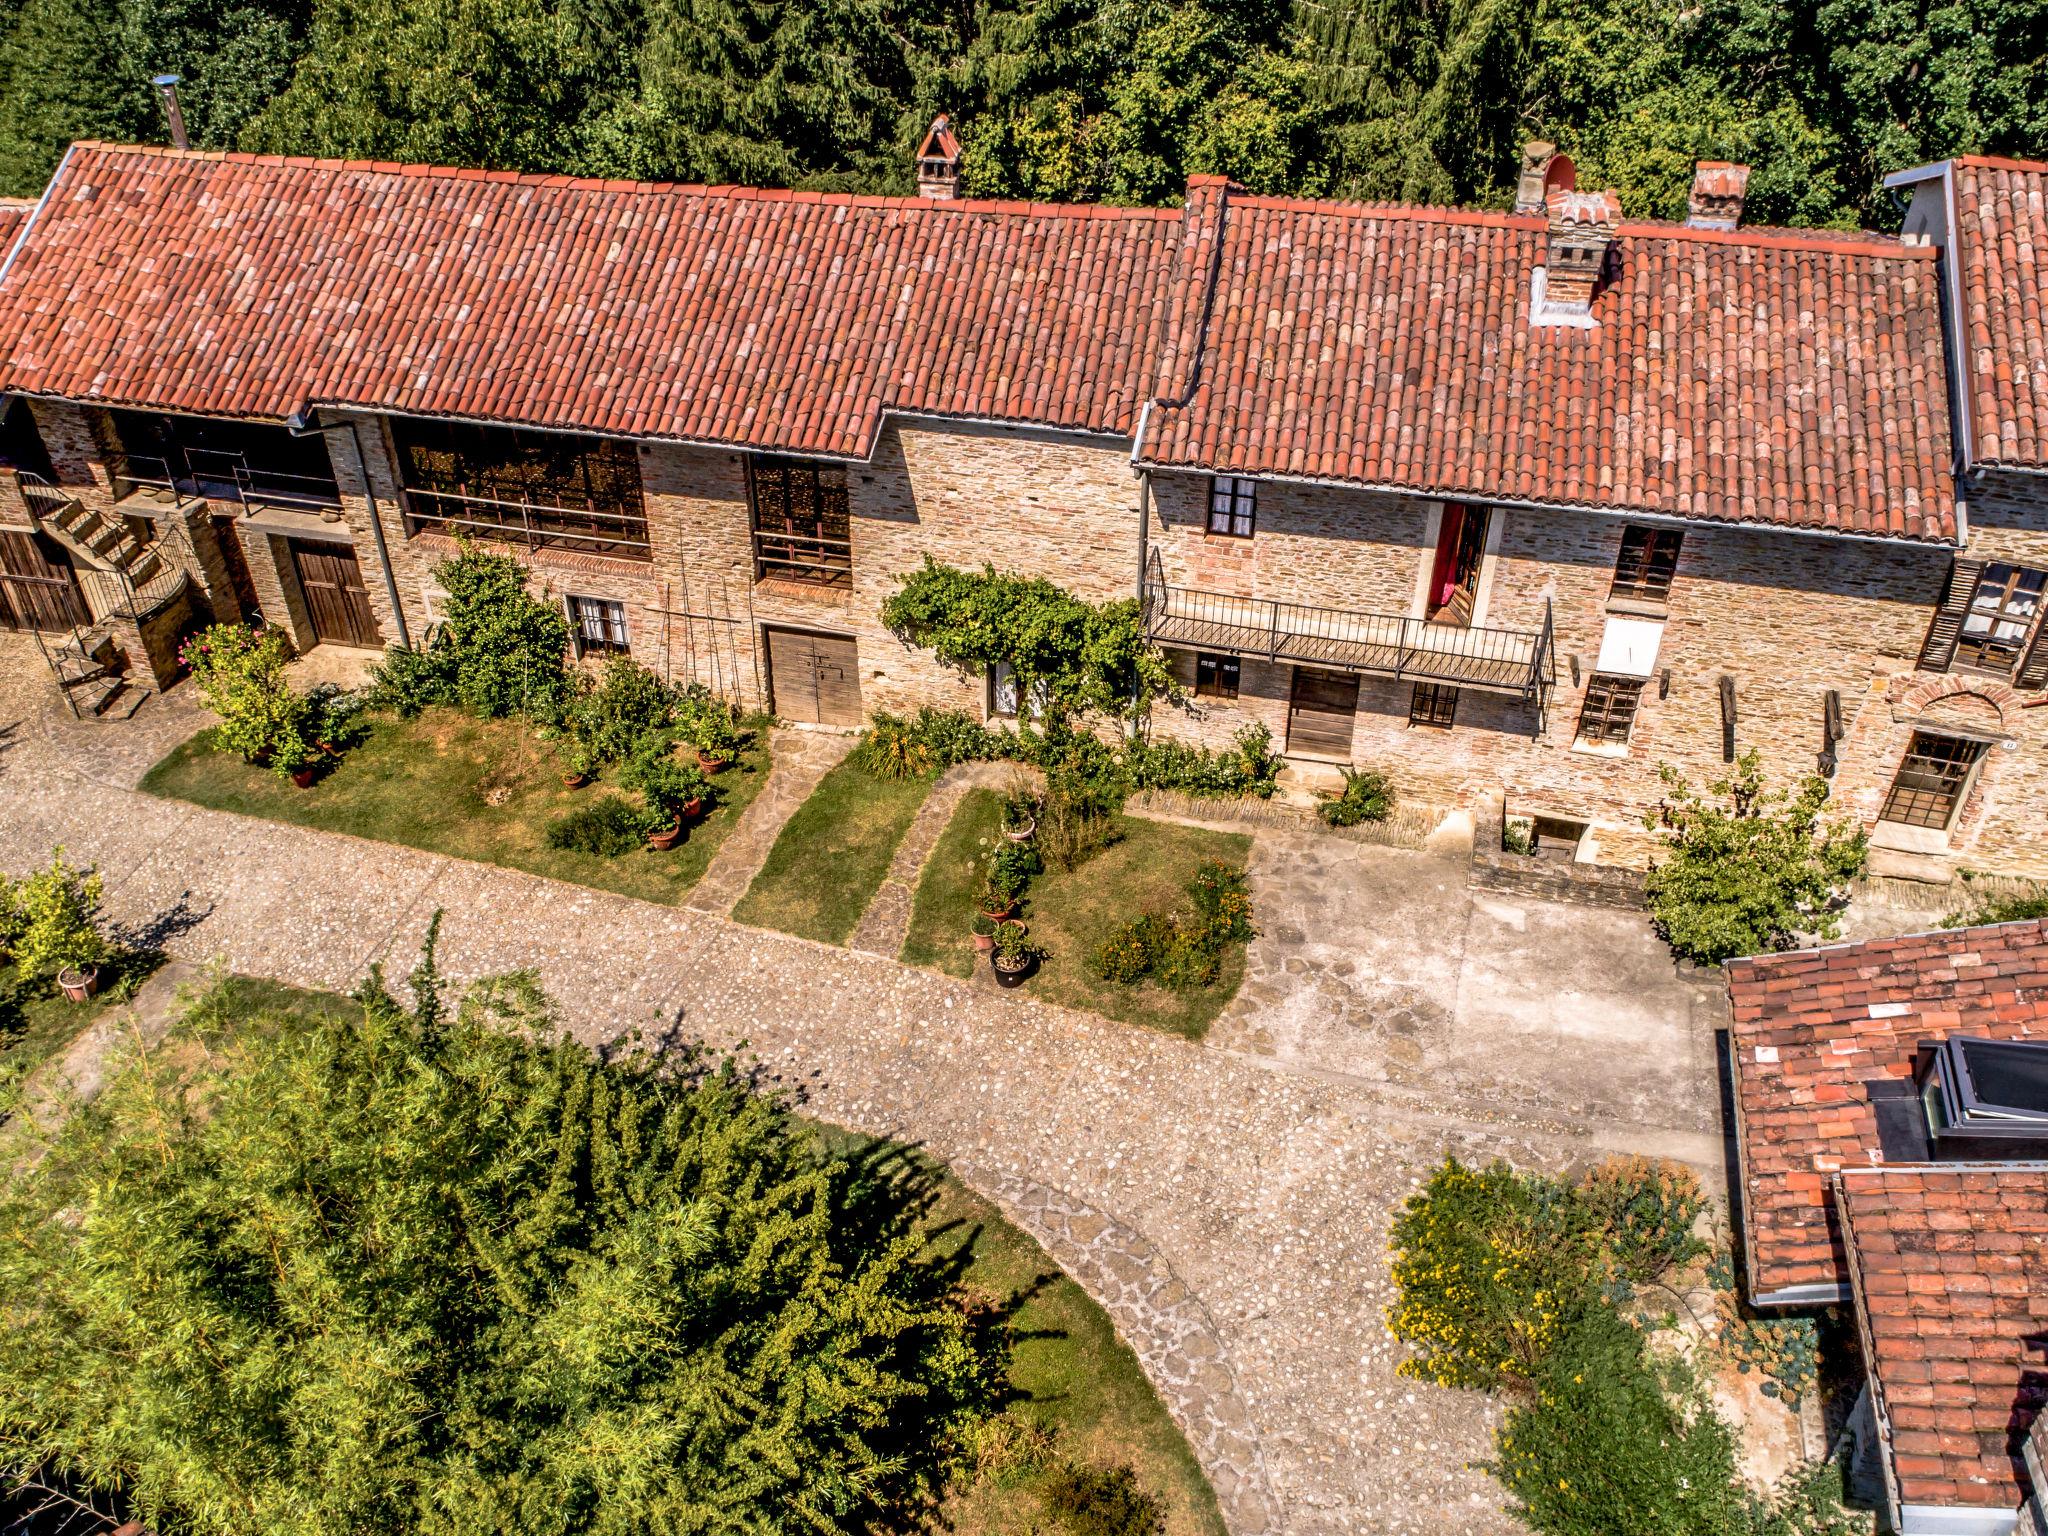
<box><xmin>819</xmin><ymin>1126</ymin><xmax>1225</xmax><ymax>1536</ymax></box>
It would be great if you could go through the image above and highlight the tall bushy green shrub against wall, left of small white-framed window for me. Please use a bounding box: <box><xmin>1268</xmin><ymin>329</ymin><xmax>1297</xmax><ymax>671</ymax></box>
<box><xmin>434</xmin><ymin>547</ymin><xmax>569</xmax><ymax>723</ymax></box>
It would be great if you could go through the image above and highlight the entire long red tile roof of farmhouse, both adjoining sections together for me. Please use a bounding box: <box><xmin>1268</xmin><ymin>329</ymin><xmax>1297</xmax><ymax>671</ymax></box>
<box><xmin>0</xmin><ymin>143</ymin><xmax>1956</xmax><ymax>541</ymax></box>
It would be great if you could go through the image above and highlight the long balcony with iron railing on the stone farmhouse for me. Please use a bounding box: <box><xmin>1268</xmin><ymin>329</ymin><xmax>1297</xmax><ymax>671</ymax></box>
<box><xmin>1143</xmin><ymin>549</ymin><xmax>1556</xmax><ymax>705</ymax></box>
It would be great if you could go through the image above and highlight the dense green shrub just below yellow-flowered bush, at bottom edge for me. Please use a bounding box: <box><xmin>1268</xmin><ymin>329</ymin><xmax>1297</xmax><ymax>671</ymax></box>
<box><xmin>1495</xmin><ymin>1305</ymin><xmax>1753</xmax><ymax>1536</ymax></box>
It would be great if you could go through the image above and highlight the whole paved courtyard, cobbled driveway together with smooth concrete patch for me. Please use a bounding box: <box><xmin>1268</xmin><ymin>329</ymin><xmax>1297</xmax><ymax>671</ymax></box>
<box><xmin>0</xmin><ymin>635</ymin><xmax>1720</xmax><ymax>1536</ymax></box>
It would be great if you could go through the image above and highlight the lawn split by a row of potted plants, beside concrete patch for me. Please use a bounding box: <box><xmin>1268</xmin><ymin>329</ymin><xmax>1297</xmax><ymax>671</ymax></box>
<box><xmin>901</xmin><ymin>788</ymin><xmax>1257</xmax><ymax>1040</ymax></box>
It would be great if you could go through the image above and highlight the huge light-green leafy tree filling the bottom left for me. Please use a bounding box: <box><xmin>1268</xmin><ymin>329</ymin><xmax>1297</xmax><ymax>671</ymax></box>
<box><xmin>0</xmin><ymin>946</ymin><xmax>1001</xmax><ymax>1536</ymax></box>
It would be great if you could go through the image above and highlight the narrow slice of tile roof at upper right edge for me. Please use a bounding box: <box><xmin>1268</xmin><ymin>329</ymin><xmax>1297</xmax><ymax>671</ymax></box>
<box><xmin>1952</xmin><ymin>156</ymin><xmax>2048</xmax><ymax>467</ymax></box>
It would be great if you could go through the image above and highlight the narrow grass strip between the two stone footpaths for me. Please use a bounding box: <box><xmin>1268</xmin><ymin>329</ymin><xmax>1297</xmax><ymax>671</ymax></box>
<box><xmin>733</xmin><ymin>762</ymin><xmax>932</xmax><ymax>944</ymax></box>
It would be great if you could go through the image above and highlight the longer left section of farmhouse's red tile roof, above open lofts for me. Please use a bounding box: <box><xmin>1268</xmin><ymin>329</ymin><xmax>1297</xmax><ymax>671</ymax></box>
<box><xmin>0</xmin><ymin>143</ymin><xmax>1184</xmax><ymax>457</ymax></box>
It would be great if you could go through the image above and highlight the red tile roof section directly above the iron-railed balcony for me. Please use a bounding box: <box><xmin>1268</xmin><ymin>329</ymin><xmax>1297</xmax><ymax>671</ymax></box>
<box><xmin>1141</xmin><ymin>195</ymin><xmax>1956</xmax><ymax>541</ymax></box>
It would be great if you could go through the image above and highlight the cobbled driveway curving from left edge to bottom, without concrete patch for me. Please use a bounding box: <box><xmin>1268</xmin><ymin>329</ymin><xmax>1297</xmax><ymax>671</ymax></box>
<box><xmin>0</xmin><ymin>637</ymin><xmax>1712</xmax><ymax>1536</ymax></box>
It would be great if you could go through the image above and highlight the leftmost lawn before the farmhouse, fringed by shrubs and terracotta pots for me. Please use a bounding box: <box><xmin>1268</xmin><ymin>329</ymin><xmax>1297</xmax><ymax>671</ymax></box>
<box><xmin>141</xmin><ymin>709</ymin><xmax>768</xmax><ymax>903</ymax></box>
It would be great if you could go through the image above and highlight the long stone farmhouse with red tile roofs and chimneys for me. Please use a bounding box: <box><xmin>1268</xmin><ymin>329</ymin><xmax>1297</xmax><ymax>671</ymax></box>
<box><xmin>0</xmin><ymin>119</ymin><xmax>2048</xmax><ymax>879</ymax></box>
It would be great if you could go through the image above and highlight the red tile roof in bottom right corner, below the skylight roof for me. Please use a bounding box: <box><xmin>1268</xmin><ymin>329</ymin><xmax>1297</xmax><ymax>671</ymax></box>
<box><xmin>1837</xmin><ymin>1165</ymin><xmax>2048</xmax><ymax>1509</ymax></box>
